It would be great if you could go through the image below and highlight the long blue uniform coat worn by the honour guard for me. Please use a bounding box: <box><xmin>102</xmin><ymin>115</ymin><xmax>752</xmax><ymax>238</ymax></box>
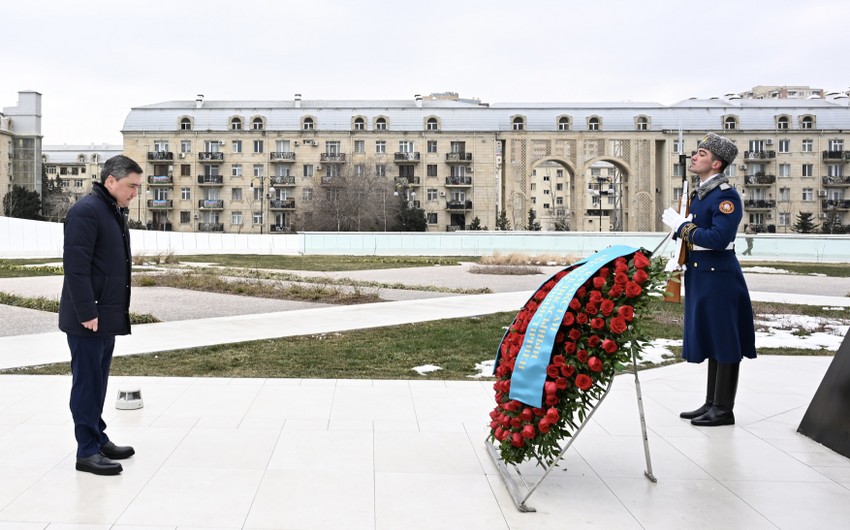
<box><xmin>677</xmin><ymin>184</ymin><xmax>756</xmax><ymax>363</ymax></box>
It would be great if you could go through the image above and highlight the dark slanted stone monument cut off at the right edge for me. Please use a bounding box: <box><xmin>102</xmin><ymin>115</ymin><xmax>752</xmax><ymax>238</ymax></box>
<box><xmin>797</xmin><ymin>333</ymin><xmax>850</xmax><ymax>458</ymax></box>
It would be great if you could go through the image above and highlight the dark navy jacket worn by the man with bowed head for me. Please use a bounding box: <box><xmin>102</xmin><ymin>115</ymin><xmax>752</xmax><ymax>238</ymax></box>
<box><xmin>59</xmin><ymin>183</ymin><xmax>132</xmax><ymax>336</ymax></box>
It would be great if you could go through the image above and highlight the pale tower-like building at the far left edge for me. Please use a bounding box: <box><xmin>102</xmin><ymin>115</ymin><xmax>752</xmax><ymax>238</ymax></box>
<box><xmin>0</xmin><ymin>90</ymin><xmax>42</xmax><ymax>197</ymax></box>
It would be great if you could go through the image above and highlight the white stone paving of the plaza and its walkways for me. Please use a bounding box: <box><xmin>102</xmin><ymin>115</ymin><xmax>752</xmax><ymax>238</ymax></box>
<box><xmin>0</xmin><ymin>267</ymin><xmax>850</xmax><ymax>530</ymax></box>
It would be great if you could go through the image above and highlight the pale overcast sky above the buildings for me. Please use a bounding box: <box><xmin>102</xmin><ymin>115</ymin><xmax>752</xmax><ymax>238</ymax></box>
<box><xmin>0</xmin><ymin>0</ymin><xmax>850</xmax><ymax>144</ymax></box>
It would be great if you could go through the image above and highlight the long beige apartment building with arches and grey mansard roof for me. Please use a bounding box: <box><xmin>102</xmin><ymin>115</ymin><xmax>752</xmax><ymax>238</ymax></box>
<box><xmin>122</xmin><ymin>93</ymin><xmax>850</xmax><ymax>233</ymax></box>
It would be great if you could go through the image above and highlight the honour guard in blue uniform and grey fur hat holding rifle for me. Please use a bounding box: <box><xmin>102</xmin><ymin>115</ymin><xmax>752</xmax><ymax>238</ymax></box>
<box><xmin>662</xmin><ymin>134</ymin><xmax>756</xmax><ymax>427</ymax></box>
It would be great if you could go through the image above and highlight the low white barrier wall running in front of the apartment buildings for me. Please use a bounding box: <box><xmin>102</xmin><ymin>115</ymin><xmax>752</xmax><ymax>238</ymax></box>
<box><xmin>0</xmin><ymin>217</ymin><xmax>850</xmax><ymax>263</ymax></box>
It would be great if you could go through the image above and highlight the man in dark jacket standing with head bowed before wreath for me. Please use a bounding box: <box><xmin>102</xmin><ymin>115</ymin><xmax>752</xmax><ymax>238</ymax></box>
<box><xmin>59</xmin><ymin>155</ymin><xmax>142</xmax><ymax>475</ymax></box>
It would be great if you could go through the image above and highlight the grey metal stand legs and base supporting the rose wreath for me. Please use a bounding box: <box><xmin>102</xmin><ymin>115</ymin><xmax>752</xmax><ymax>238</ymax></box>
<box><xmin>485</xmin><ymin>352</ymin><xmax>658</xmax><ymax>512</ymax></box>
